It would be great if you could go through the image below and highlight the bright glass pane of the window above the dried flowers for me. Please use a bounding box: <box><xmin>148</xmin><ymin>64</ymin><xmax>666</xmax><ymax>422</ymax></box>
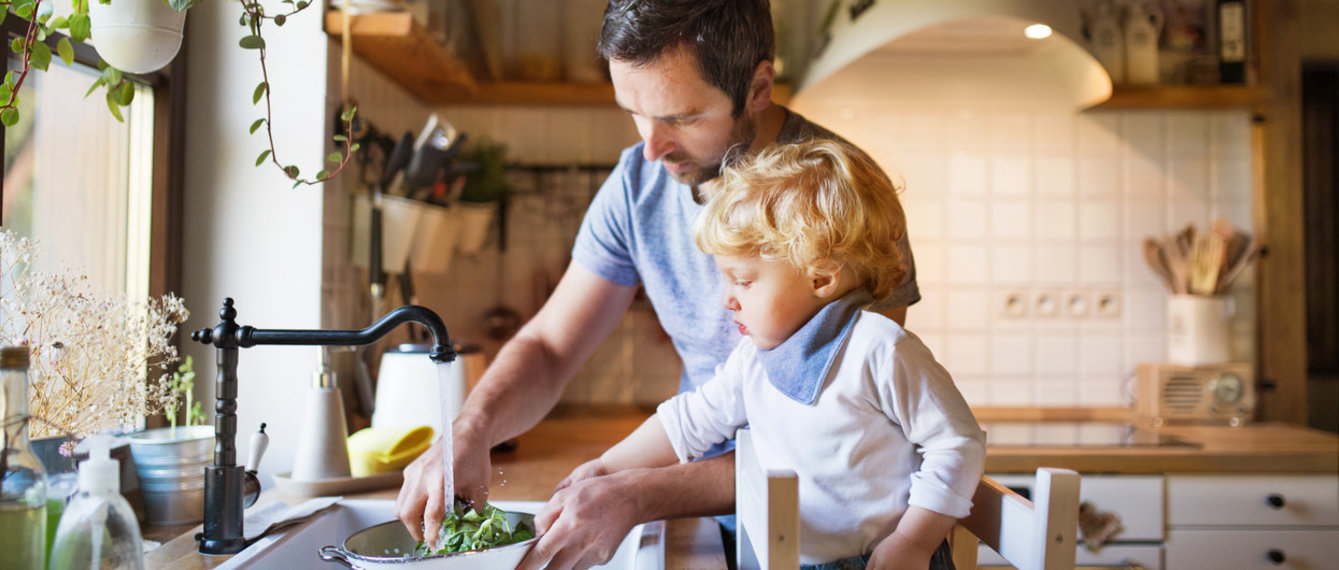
<box><xmin>0</xmin><ymin>60</ymin><xmax>154</xmax><ymax>297</ymax></box>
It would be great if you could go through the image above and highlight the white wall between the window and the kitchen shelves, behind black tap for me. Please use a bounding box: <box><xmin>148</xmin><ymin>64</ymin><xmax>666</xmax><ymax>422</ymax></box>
<box><xmin>182</xmin><ymin>1</ymin><xmax>329</xmax><ymax>483</ymax></box>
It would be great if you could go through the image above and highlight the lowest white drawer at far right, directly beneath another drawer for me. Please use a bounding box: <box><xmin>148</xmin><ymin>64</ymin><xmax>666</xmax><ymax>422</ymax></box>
<box><xmin>1166</xmin><ymin>529</ymin><xmax>1339</xmax><ymax>570</ymax></box>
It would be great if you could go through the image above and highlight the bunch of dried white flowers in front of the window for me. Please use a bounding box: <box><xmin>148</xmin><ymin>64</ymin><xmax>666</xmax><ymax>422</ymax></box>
<box><xmin>0</xmin><ymin>229</ymin><xmax>189</xmax><ymax>438</ymax></box>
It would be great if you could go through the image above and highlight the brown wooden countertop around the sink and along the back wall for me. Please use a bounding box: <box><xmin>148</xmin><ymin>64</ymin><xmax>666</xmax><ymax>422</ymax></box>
<box><xmin>138</xmin><ymin>409</ymin><xmax>1339</xmax><ymax>569</ymax></box>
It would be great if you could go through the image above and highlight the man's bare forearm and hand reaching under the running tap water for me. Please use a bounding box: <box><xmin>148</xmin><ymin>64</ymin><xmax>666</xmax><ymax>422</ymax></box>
<box><xmin>395</xmin><ymin>264</ymin><xmax>636</xmax><ymax>542</ymax></box>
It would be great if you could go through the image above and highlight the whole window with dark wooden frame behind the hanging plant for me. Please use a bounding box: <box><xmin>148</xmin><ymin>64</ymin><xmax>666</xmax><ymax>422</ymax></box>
<box><xmin>0</xmin><ymin>17</ymin><xmax>185</xmax><ymax>297</ymax></box>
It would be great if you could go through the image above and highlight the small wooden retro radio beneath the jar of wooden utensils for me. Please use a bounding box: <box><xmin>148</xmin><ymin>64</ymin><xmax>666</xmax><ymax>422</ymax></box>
<box><xmin>1134</xmin><ymin>363</ymin><xmax>1256</xmax><ymax>425</ymax></box>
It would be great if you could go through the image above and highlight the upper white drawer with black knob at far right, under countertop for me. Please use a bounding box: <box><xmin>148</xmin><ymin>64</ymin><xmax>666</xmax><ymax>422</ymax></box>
<box><xmin>1162</xmin><ymin>475</ymin><xmax>1339</xmax><ymax>527</ymax></box>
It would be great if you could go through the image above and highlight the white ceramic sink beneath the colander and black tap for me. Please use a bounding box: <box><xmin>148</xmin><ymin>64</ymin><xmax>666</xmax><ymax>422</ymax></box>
<box><xmin>218</xmin><ymin>499</ymin><xmax>665</xmax><ymax>570</ymax></box>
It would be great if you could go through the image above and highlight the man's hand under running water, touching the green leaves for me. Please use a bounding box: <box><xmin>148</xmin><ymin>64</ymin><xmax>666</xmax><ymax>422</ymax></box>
<box><xmin>395</xmin><ymin>428</ymin><xmax>493</xmax><ymax>547</ymax></box>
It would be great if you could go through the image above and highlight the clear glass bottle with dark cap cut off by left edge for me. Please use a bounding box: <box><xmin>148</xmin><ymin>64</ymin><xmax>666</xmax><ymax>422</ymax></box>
<box><xmin>0</xmin><ymin>347</ymin><xmax>47</xmax><ymax>569</ymax></box>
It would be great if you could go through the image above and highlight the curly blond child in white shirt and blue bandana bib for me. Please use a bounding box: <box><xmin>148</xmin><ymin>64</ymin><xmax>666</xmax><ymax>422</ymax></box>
<box><xmin>573</xmin><ymin>140</ymin><xmax>986</xmax><ymax>569</ymax></box>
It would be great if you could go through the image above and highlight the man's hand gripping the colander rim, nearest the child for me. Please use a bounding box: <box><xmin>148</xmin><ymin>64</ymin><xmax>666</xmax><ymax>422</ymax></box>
<box><xmin>517</xmin><ymin>470</ymin><xmax>640</xmax><ymax>570</ymax></box>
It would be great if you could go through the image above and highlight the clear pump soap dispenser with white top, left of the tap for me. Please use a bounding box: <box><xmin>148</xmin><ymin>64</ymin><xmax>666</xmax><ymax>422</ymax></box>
<box><xmin>50</xmin><ymin>435</ymin><xmax>145</xmax><ymax>570</ymax></box>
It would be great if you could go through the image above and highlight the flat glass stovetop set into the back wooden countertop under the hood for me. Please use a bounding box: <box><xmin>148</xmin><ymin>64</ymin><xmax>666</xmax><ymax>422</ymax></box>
<box><xmin>981</xmin><ymin>421</ymin><xmax>1197</xmax><ymax>447</ymax></box>
